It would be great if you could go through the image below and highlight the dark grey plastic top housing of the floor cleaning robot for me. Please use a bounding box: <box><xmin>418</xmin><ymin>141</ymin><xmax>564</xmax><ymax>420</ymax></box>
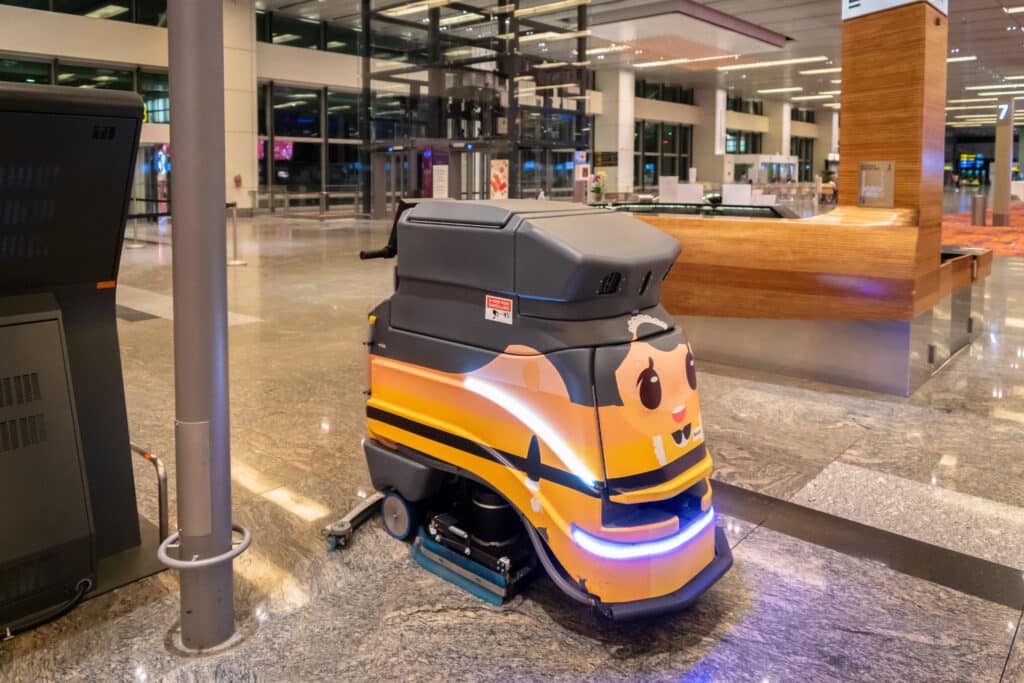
<box><xmin>397</xmin><ymin>200</ymin><xmax>680</xmax><ymax>319</ymax></box>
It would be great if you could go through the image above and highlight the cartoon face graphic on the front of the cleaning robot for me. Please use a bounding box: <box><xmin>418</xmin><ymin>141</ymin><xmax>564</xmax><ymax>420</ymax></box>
<box><xmin>615</xmin><ymin>335</ymin><xmax>702</xmax><ymax>465</ymax></box>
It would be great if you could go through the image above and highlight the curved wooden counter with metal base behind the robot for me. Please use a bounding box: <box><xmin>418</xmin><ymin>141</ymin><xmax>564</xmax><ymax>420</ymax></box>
<box><xmin>636</xmin><ymin>207</ymin><xmax>992</xmax><ymax>394</ymax></box>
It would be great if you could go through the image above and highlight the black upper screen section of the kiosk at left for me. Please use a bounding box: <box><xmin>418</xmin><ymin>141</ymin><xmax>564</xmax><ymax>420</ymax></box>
<box><xmin>0</xmin><ymin>83</ymin><xmax>142</xmax><ymax>296</ymax></box>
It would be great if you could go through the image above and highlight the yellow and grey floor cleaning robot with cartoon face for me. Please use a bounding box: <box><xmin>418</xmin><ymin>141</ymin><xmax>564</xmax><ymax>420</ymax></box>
<box><xmin>350</xmin><ymin>200</ymin><xmax>732</xmax><ymax>620</ymax></box>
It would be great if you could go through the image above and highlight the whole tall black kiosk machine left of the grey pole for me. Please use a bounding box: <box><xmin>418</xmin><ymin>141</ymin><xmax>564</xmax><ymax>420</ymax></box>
<box><xmin>0</xmin><ymin>84</ymin><xmax>160</xmax><ymax>638</ymax></box>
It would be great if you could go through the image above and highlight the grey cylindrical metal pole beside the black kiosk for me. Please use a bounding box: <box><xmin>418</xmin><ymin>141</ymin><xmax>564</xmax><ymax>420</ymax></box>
<box><xmin>167</xmin><ymin>0</ymin><xmax>234</xmax><ymax>649</ymax></box>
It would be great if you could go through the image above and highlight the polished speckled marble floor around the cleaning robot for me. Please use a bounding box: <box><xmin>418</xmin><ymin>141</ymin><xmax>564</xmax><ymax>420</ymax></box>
<box><xmin>0</xmin><ymin>217</ymin><xmax>1024</xmax><ymax>682</ymax></box>
